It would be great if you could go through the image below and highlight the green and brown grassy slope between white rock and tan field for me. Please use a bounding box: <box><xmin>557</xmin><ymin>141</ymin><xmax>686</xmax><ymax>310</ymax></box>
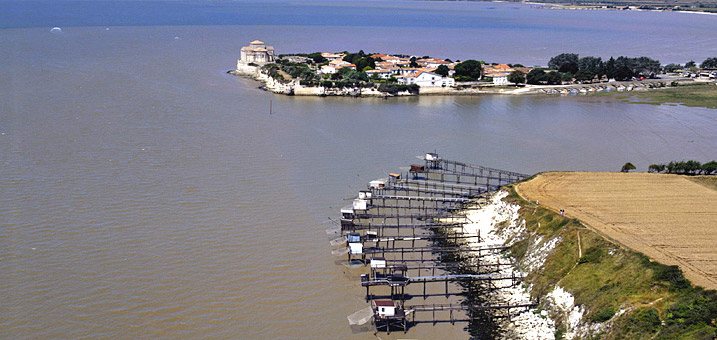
<box><xmin>506</xmin><ymin>187</ymin><xmax>717</xmax><ymax>339</ymax></box>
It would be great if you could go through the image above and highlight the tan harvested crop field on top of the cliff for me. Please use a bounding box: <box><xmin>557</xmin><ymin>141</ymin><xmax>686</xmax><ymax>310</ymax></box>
<box><xmin>516</xmin><ymin>172</ymin><xmax>717</xmax><ymax>289</ymax></box>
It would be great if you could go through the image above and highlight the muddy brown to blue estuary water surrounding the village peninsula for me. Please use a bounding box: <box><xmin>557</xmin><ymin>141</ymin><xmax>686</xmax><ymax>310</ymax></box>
<box><xmin>0</xmin><ymin>1</ymin><xmax>717</xmax><ymax>339</ymax></box>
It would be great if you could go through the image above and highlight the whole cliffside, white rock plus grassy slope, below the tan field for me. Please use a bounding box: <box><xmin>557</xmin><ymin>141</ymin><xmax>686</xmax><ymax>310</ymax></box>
<box><xmin>466</xmin><ymin>187</ymin><xmax>717</xmax><ymax>339</ymax></box>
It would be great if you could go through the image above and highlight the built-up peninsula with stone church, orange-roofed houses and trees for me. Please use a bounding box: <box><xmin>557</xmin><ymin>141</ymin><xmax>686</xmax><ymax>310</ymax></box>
<box><xmin>229</xmin><ymin>40</ymin><xmax>717</xmax><ymax>101</ymax></box>
